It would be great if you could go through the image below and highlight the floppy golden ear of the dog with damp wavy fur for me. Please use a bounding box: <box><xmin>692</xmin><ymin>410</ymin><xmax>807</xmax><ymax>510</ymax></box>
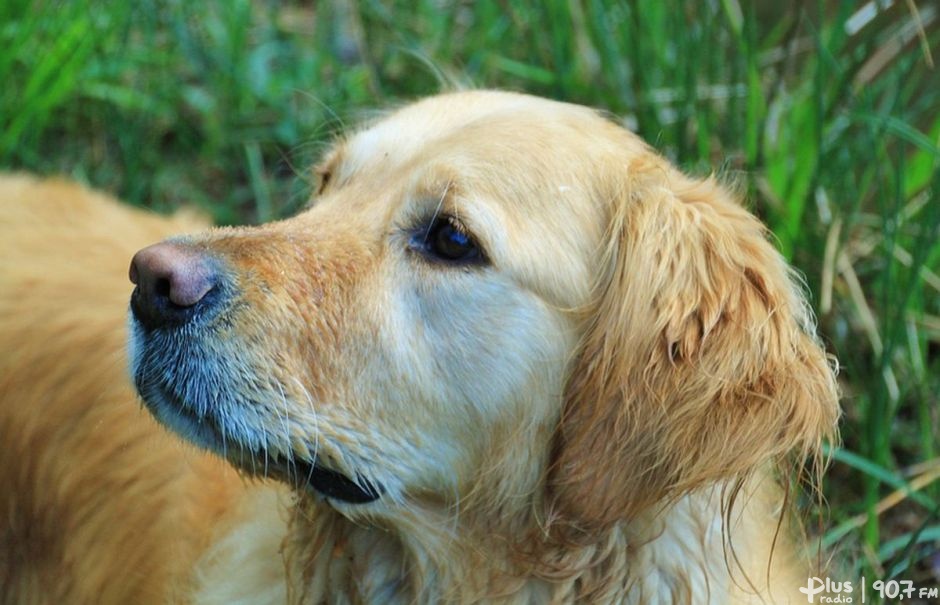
<box><xmin>550</xmin><ymin>155</ymin><xmax>839</xmax><ymax>531</ymax></box>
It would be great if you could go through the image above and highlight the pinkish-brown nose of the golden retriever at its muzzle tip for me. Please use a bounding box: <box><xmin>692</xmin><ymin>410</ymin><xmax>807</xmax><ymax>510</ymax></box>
<box><xmin>129</xmin><ymin>242</ymin><xmax>219</xmax><ymax>328</ymax></box>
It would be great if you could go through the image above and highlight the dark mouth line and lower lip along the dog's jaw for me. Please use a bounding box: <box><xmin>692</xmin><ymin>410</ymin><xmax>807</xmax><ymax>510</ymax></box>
<box><xmin>135</xmin><ymin>375</ymin><xmax>385</xmax><ymax>504</ymax></box>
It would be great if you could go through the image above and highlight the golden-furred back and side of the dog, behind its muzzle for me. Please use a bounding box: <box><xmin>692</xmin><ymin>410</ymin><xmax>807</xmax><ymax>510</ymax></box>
<box><xmin>0</xmin><ymin>176</ymin><xmax>250</xmax><ymax>604</ymax></box>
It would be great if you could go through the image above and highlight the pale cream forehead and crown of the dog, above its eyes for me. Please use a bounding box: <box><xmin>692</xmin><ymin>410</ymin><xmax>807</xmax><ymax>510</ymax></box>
<box><xmin>331</xmin><ymin>91</ymin><xmax>648</xmax><ymax>221</ymax></box>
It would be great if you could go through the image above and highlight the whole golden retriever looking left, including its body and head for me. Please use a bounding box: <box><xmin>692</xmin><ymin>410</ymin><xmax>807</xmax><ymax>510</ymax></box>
<box><xmin>0</xmin><ymin>91</ymin><xmax>839</xmax><ymax>605</ymax></box>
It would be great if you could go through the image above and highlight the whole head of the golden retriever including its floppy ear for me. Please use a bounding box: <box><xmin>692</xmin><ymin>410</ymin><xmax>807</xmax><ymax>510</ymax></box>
<box><xmin>130</xmin><ymin>92</ymin><xmax>837</xmax><ymax>528</ymax></box>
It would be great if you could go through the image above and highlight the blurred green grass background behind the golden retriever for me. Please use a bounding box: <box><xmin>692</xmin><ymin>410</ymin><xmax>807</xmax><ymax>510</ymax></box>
<box><xmin>0</xmin><ymin>0</ymin><xmax>940</xmax><ymax>602</ymax></box>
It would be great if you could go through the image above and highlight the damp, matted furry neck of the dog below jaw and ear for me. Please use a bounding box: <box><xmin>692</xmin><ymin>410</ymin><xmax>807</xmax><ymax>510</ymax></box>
<box><xmin>282</xmin><ymin>486</ymin><xmax>744</xmax><ymax>603</ymax></box>
